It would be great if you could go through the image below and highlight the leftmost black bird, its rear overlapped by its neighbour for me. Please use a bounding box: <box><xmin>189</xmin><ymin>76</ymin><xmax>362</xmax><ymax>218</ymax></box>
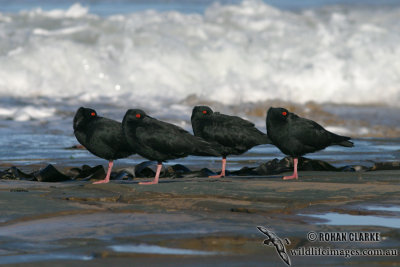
<box><xmin>74</xmin><ymin>107</ymin><xmax>135</xmax><ymax>184</ymax></box>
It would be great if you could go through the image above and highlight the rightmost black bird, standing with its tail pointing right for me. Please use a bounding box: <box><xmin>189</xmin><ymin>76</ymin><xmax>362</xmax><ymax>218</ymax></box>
<box><xmin>266</xmin><ymin>107</ymin><xmax>354</xmax><ymax>180</ymax></box>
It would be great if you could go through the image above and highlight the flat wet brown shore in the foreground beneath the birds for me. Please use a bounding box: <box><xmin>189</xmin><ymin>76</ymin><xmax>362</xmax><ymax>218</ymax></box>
<box><xmin>0</xmin><ymin>170</ymin><xmax>400</xmax><ymax>266</ymax></box>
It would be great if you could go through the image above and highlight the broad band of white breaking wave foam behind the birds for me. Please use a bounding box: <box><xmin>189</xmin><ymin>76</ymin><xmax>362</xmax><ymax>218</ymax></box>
<box><xmin>0</xmin><ymin>1</ymin><xmax>400</xmax><ymax>119</ymax></box>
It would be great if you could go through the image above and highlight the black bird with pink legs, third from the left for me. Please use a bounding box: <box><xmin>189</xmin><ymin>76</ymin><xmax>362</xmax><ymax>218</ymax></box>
<box><xmin>191</xmin><ymin>106</ymin><xmax>271</xmax><ymax>178</ymax></box>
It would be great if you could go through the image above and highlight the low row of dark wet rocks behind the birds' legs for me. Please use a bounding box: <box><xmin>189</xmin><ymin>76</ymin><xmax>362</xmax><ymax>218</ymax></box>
<box><xmin>0</xmin><ymin>157</ymin><xmax>394</xmax><ymax>182</ymax></box>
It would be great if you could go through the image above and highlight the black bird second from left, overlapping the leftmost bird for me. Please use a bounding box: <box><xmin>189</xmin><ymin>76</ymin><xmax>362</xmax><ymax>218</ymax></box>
<box><xmin>122</xmin><ymin>109</ymin><xmax>220</xmax><ymax>184</ymax></box>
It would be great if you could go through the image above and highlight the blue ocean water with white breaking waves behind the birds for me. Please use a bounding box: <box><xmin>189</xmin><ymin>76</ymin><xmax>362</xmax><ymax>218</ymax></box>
<box><xmin>0</xmin><ymin>0</ymin><xmax>400</xmax><ymax>168</ymax></box>
